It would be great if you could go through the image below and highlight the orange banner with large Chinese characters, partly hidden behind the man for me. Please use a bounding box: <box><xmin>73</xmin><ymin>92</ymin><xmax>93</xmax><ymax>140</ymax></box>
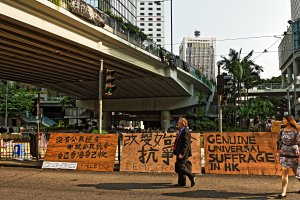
<box><xmin>120</xmin><ymin>133</ymin><xmax>201</xmax><ymax>173</ymax></box>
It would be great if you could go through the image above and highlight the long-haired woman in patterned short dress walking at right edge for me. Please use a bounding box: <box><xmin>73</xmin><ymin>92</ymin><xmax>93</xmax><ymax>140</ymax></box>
<box><xmin>276</xmin><ymin>115</ymin><xmax>300</xmax><ymax>199</ymax></box>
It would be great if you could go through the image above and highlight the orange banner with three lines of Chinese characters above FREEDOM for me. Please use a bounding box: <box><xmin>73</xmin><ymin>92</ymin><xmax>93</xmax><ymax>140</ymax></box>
<box><xmin>44</xmin><ymin>133</ymin><xmax>118</xmax><ymax>171</ymax></box>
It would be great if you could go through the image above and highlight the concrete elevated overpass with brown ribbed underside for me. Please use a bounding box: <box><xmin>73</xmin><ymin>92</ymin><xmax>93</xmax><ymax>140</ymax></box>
<box><xmin>0</xmin><ymin>0</ymin><xmax>215</xmax><ymax>119</ymax></box>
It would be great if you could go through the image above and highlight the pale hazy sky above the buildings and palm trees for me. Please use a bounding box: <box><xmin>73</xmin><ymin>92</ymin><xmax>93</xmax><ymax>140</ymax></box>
<box><xmin>165</xmin><ymin>0</ymin><xmax>291</xmax><ymax>78</ymax></box>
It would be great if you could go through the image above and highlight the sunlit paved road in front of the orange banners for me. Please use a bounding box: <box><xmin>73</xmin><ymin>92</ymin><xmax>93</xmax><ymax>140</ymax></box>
<box><xmin>0</xmin><ymin>167</ymin><xmax>300</xmax><ymax>200</ymax></box>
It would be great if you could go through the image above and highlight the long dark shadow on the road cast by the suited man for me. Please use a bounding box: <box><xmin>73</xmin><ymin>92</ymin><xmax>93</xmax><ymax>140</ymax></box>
<box><xmin>77</xmin><ymin>183</ymin><xmax>175</xmax><ymax>191</ymax></box>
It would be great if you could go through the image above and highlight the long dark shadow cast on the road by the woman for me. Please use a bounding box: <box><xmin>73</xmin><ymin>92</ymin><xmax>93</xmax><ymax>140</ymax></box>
<box><xmin>161</xmin><ymin>190</ymin><xmax>277</xmax><ymax>199</ymax></box>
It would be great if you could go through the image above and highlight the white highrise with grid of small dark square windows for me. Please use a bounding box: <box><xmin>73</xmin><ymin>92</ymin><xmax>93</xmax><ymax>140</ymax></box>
<box><xmin>137</xmin><ymin>0</ymin><xmax>165</xmax><ymax>46</ymax></box>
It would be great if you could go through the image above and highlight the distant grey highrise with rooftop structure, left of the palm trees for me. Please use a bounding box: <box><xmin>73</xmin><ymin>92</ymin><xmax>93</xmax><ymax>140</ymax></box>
<box><xmin>179</xmin><ymin>31</ymin><xmax>216</xmax><ymax>80</ymax></box>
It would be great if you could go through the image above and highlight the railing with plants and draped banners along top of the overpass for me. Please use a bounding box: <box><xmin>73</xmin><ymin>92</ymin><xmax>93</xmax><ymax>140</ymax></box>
<box><xmin>48</xmin><ymin>0</ymin><xmax>216</xmax><ymax>92</ymax></box>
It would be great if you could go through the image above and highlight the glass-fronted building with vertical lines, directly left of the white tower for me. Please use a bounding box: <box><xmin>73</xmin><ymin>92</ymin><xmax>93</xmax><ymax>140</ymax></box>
<box><xmin>84</xmin><ymin>0</ymin><xmax>137</xmax><ymax>25</ymax></box>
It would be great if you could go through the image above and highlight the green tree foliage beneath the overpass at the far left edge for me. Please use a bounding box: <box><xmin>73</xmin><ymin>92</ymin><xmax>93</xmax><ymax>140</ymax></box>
<box><xmin>0</xmin><ymin>82</ymin><xmax>34</xmax><ymax>114</ymax></box>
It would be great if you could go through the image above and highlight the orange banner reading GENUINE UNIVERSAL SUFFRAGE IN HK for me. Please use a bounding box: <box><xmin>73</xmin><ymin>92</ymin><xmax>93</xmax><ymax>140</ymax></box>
<box><xmin>204</xmin><ymin>132</ymin><xmax>280</xmax><ymax>175</ymax></box>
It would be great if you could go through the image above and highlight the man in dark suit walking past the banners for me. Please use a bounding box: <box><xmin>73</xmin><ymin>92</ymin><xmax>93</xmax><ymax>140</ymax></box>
<box><xmin>173</xmin><ymin>118</ymin><xmax>196</xmax><ymax>187</ymax></box>
